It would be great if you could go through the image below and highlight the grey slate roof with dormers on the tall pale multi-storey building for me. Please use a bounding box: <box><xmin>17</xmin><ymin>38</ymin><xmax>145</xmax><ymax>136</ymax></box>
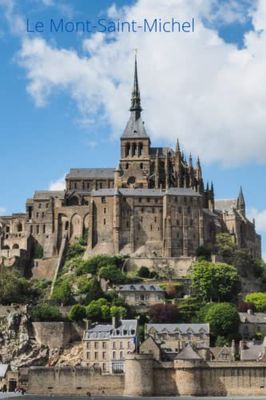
<box><xmin>83</xmin><ymin>319</ymin><xmax>138</xmax><ymax>340</ymax></box>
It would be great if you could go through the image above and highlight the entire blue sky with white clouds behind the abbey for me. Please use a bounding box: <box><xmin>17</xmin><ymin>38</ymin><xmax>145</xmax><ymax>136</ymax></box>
<box><xmin>0</xmin><ymin>0</ymin><xmax>266</xmax><ymax>260</ymax></box>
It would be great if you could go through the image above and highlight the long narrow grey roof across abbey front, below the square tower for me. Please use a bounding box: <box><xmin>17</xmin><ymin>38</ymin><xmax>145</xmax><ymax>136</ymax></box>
<box><xmin>91</xmin><ymin>188</ymin><xmax>201</xmax><ymax>197</ymax></box>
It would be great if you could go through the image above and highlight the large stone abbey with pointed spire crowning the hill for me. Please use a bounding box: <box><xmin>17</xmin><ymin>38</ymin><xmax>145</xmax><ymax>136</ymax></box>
<box><xmin>0</xmin><ymin>60</ymin><xmax>261</xmax><ymax>274</ymax></box>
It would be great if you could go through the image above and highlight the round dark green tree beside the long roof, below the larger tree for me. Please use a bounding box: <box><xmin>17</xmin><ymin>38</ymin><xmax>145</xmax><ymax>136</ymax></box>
<box><xmin>198</xmin><ymin>303</ymin><xmax>240</xmax><ymax>340</ymax></box>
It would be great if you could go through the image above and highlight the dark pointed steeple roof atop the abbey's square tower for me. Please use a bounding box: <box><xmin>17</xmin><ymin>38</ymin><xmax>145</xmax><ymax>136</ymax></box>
<box><xmin>121</xmin><ymin>56</ymin><xmax>149</xmax><ymax>139</ymax></box>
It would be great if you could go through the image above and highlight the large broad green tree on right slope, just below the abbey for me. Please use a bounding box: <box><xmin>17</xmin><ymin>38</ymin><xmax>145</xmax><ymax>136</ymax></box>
<box><xmin>191</xmin><ymin>260</ymin><xmax>241</xmax><ymax>301</ymax></box>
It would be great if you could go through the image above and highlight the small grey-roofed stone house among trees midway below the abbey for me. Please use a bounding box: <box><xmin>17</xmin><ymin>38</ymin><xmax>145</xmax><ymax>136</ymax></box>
<box><xmin>117</xmin><ymin>284</ymin><xmax>165</xmax><ymax>308</ymax></box>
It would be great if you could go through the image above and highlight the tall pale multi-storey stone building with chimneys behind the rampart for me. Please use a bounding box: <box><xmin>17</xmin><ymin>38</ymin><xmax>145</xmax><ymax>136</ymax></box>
<box><xmin>83</xmin><ymin>318</ymin><xmax>138</xmax><ymax>373</ymax></box>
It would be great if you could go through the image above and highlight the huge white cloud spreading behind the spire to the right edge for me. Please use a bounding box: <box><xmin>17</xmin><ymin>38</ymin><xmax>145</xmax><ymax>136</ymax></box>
<box><xmin>1</xmin><ymin>0</ymin><xmax>266</xmax><ymax>165</ymax></box>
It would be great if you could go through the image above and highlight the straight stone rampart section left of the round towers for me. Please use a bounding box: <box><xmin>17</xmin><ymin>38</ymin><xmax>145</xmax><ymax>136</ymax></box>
<box><xmin>28</xmin><ymin>367</ymin><xmax>124</xmax><ymax>395</ymax></box>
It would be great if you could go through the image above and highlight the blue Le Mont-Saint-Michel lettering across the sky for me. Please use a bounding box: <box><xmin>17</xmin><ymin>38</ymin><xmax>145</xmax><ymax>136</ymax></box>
<box><xmin>26</xmin><ymin>18</ymin><xmax>195</xmax><ymax>33</ymax></box>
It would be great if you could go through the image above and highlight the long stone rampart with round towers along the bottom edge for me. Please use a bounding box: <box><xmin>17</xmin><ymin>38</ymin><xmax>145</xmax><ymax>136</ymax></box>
<box><xmin>25</xmin><ymin>354</ymin><xmax>266</xmax><ymax>397</ymax></box>
